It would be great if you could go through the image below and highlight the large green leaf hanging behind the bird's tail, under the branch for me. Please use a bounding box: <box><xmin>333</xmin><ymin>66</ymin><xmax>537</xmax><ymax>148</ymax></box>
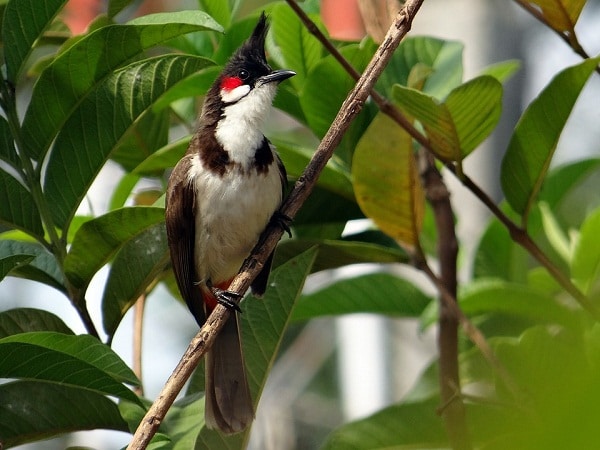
<box><xmin>195</xmin><ymin>248</ymin><xmax>317</xmax><ymax>449</ymax></box>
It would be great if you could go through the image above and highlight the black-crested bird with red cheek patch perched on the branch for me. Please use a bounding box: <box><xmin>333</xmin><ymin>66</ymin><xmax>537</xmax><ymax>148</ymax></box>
<box><xmin>165</xmin><ymin>12</ymin><xmax>295</xmax><ymax>434</ymax></box>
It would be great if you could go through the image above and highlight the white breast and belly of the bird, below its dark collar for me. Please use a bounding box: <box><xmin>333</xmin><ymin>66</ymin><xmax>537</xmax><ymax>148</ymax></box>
<box><xmin>190</xmin><ymin>156</ymin><xmax>281</xmax><ymax>284</ymax></box>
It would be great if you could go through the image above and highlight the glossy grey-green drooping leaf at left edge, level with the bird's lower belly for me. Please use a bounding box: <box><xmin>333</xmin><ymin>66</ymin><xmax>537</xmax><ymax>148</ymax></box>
<box><xmin>0</xmin><ymin>240</ymin><xmax>67</xmax><ymax>294</ymax></box>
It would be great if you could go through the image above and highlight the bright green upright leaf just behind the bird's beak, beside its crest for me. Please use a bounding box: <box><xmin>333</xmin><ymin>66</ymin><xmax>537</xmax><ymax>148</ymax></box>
<box><xmin>271</xmin><ymin>4</ymin><xmax>325</xmax><ymax>94</ymax></box>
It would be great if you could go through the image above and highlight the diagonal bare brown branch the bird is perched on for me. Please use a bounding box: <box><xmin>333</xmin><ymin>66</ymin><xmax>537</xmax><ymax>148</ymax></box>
<box><xmin>128</xmin><ymin>0</ymin><xmax>423</xmax><ymax>450</ymax></box>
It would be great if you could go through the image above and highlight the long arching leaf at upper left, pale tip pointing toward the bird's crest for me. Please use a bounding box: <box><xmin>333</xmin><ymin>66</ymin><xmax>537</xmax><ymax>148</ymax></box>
<box><xmin>23</xmin><ymin>11</ymin><xmax>221</xmax><ymax>163</ymax></box>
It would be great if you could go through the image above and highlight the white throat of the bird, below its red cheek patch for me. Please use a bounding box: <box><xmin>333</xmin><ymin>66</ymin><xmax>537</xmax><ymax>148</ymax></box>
<box><xmin>215</xmin><ymin>83</ymin><xmax>277</xmax><ymax>169</ymax></box>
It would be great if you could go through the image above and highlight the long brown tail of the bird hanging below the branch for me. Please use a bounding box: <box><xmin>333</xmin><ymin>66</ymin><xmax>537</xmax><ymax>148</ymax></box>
<box><xmin>204</xmin><ymin>312</ymin><xmax>254</xmax><ymax>434</ymax></box>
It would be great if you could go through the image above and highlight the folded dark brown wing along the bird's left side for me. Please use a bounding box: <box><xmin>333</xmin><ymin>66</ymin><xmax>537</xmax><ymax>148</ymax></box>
<box><xmin>165</xmin><ymin>155</ymin><xmax>206</xmax><ymax>326</ymax></box>
